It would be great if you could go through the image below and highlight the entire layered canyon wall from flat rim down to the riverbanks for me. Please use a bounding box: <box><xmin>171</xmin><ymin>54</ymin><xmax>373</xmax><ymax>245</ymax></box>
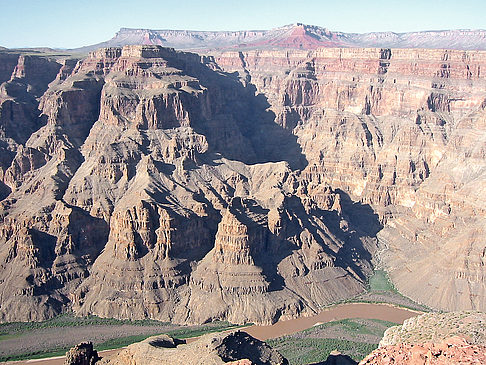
<box><xmin>0</xmin><ymin>33</ymin><xmax>486</xmax><ymax>324</ymax></box>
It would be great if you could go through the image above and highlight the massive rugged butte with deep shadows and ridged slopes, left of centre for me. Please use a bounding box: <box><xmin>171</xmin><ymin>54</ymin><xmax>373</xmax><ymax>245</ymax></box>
<box><xmin>0</xmin><ymin>46</ymin><xmax>374</xmax><ymax>323</ymax></box>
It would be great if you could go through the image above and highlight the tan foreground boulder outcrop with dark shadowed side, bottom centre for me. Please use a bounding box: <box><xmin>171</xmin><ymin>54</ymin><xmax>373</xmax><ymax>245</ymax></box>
<box><xmin>99</xmin><ymin>331</ymin><xmax>288</xmax><ymax>365</ymax></box>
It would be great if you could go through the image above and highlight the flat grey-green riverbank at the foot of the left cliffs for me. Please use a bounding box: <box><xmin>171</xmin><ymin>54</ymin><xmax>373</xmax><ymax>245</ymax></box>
<box><xmin>0</xmin><ymin>314</ymin><xmax>239</xmax><ymax>363</ymax></box>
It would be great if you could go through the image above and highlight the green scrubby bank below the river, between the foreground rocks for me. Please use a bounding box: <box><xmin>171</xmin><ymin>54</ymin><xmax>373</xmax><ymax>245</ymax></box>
<box><xmin>267</xmin><ymin>319</ymin><xmax>395</xmax><ymax>365</ymax></box>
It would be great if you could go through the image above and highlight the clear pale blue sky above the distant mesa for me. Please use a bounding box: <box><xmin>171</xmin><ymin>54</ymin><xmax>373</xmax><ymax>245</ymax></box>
<box><xmin>0</xmin><ymin>0</ymin><xmax>486</xmax><ymax>48</ymax></box>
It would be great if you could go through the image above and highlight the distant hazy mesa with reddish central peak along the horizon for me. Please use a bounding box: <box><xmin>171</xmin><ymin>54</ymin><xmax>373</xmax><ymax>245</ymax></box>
<box><xmin>76</xmin><ymin>23</ymin><xmax>486</xmax><ymax>52</ymax></box>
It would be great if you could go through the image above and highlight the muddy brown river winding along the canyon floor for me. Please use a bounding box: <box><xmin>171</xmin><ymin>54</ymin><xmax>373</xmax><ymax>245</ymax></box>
<box><xmin>9</xmin><ymin>303</ymin><xmax>421</xmax><ymax>365</ymax></box>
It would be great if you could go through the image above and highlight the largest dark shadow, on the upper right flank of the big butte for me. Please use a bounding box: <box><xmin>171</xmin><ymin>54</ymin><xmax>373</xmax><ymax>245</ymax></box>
<box><xmin>158</xmin><ymin>52</ymin><xmax>307</xmax><ymax>169</ymax></box>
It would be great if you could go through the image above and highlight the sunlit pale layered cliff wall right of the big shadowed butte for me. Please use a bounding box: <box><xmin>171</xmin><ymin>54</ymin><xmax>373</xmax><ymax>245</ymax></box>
<box><xmin>216</xmin><ymin>49</ymin><xmax>486</xmax><ymax>310</ymax></box>
